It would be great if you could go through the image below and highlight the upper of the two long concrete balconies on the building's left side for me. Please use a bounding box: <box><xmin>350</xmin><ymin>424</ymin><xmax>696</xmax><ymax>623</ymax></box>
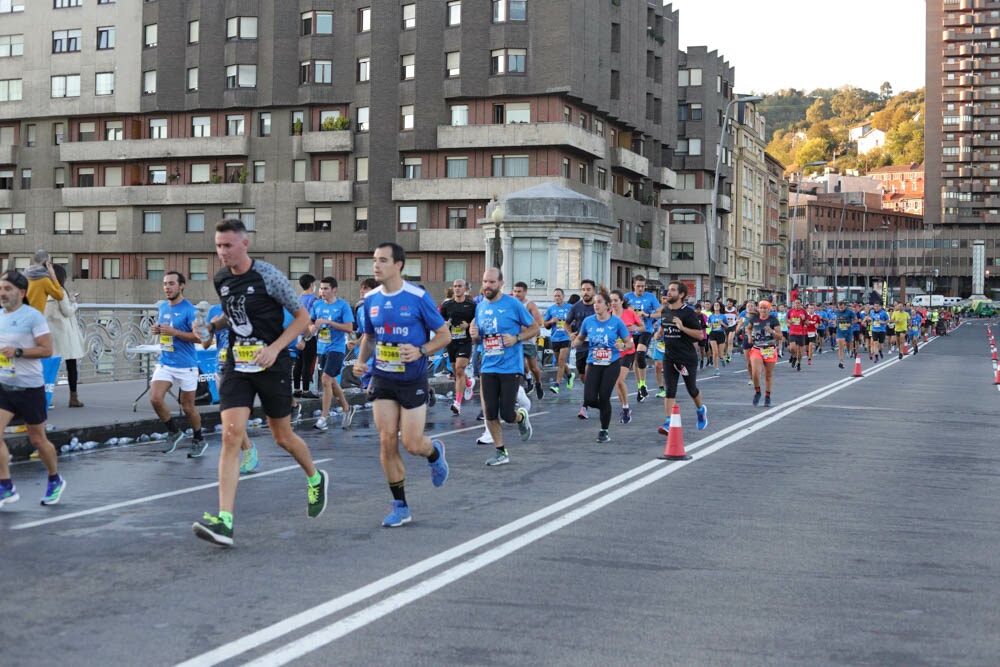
<box><xmin>59</xmin><ymin>137</ymin><xmax>250</xmax><ymax>162</ymax></box>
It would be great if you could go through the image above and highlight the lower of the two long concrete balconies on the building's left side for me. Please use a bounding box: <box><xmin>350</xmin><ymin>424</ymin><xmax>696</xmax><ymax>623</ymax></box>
<box><xmin>60</xmin><ymin>183</ymin><xmax>243</xmax><ymax>206</ymax></box>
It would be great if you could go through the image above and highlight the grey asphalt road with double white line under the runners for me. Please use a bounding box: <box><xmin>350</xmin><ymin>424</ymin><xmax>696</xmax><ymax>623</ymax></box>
<box><xmin>0</xmin><ymin>322</ymin><xmax>1000</xmax><ymax>667</ymax></box>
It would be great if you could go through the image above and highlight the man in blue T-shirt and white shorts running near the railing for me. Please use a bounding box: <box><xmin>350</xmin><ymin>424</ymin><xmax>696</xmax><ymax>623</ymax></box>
<box><xmin>149</xmin><ymin>271</ymin><xmax>207</xmax><ymax>458</ymax></box>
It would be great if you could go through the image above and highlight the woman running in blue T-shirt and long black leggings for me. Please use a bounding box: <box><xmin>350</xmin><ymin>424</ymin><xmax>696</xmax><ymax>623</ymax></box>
<box><xmin>573</xmin><ymin>292</ymin><xmax>634</xmax><ymax>442</ymax></box>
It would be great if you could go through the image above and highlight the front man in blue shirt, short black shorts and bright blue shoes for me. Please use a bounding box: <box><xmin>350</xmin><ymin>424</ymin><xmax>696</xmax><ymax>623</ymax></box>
<box><xmin>354</xmin><ymin>242</ymin><xmax>451</xmax><ymax>528</ymax></box>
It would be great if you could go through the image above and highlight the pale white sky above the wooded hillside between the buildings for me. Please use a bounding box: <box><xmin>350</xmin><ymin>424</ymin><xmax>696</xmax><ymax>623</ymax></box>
<box><xmin>668</xmin><ymin>0</ymin><xmax>926</xmax><ymax>94</ymax></box>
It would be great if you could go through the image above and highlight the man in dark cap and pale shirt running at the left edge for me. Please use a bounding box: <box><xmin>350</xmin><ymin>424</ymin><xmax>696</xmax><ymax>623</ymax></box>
<box><xmin>0</xmin><ymin>271</ymin><xmax>66</xmax><ymax>507</ymax></box>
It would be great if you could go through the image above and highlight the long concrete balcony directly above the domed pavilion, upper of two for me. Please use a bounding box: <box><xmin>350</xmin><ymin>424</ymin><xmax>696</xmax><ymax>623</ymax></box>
<box><xmin>438</xmin><ymin>123</ymin><xmax>606</xmax><ymax>159</ymax></box>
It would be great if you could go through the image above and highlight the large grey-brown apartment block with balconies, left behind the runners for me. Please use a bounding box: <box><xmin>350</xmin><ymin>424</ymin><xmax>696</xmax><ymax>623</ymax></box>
<box><xmin>0</xmin><ymin>0</ymin><xmax>680</xmax><ymax>302</ymax></box>
